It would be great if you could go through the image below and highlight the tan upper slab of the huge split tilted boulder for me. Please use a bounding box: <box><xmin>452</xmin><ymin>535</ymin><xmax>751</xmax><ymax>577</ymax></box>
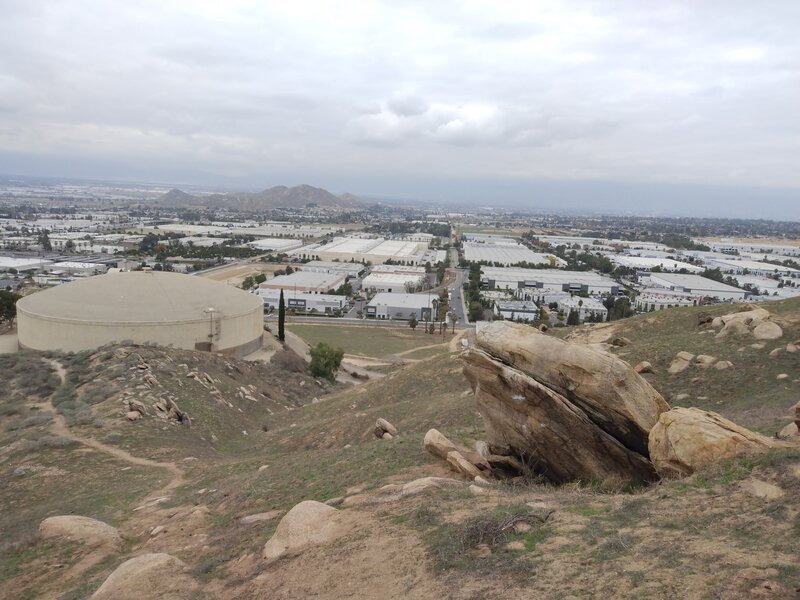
<box><xmin>468</xmin><ymin>321</ymin><xmax>669</xmax><ymax>454</ymax></box>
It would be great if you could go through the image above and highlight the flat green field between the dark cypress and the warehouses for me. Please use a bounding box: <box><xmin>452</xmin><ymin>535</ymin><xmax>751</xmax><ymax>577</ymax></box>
<box><xmin>287</xmin><ymin>324</ymin><xmax>452</xmax><ymax>358</ymax></box>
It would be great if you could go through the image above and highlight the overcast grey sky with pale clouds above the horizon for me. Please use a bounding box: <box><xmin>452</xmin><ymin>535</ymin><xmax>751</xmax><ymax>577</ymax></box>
<box><xmin>0</xmin><ymin>0</ymin><xmax>800</xmax><ymax>218</ymax></box>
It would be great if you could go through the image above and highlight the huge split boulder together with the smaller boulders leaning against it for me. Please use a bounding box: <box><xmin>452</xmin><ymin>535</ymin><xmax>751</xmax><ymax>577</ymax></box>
<box><xmin>440</xmin><ymin>322</ymin><xmax>783</xmax><ymax>483</ymax></box>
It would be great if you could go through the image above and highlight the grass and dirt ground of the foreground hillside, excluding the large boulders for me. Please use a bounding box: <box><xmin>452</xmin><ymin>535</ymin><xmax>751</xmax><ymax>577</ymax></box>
<box><xmin>0</xmin><ymin>301</ymin><xmax>800</xmax><ymax>599</ymax></box>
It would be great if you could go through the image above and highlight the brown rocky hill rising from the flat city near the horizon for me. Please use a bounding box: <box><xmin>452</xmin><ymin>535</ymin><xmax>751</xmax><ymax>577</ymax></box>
<box><xmin>157</xmin><ymin>185</ymin><xmax>372</xmax><ymax>212</ymax></box>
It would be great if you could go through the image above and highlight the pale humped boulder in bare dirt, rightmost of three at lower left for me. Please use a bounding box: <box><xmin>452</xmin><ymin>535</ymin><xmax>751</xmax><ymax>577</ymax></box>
<box><xmin>263</xmin><ymin>500</ymin><xmax>345</xmax><ymax>560</ymax></box>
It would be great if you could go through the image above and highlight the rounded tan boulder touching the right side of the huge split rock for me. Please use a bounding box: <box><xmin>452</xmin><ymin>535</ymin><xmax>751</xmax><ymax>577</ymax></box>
<box><xmin>650</xmin><ymin>408</ymin><xmax>784</xmax><ymax>477</ymax></box>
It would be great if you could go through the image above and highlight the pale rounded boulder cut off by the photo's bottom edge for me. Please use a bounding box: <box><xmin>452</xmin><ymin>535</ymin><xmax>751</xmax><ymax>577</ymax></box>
<box><xmin>91</xmin><ymin>553</ymin><xmax>205</xmax><ymax>600</ymax></box>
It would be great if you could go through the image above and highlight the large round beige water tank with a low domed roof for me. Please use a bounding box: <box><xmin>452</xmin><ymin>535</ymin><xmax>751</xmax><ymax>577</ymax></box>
<box><xmin>17</xmin><ymin>271</ymin><xmax>264</xmax><ymax>356</ymax></box>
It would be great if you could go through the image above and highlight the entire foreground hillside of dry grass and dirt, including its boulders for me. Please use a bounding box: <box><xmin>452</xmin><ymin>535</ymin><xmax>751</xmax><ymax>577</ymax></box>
<box><xmin>0</xmin><ymin>300</ymin><xmax>800</xmax><ymax>600</ymax></box>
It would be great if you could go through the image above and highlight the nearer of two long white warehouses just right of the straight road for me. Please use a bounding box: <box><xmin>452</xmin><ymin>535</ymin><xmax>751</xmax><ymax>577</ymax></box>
<box><xmin>481</xmin><ymin>267</ymin><xmax>619</xmax><ymax>302</ymax></box>
